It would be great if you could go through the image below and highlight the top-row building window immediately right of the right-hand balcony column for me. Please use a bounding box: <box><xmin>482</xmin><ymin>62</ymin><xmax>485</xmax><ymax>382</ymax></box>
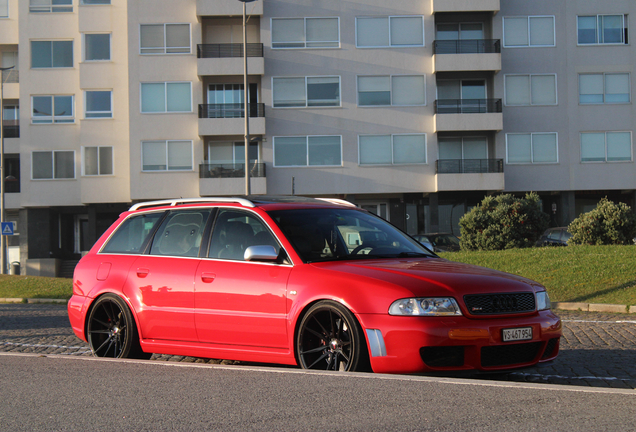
<box><xmin>503</xmin><ymin>16</ymin><xmax>556</xmax><ymax>48</ymax></box>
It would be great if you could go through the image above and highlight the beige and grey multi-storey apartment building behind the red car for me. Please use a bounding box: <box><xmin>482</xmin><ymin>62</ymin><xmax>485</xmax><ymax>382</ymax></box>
<box><xmin>0</xmin><ymin>0</ymin><xmax>636</xmax><ymax>274</ymax></box>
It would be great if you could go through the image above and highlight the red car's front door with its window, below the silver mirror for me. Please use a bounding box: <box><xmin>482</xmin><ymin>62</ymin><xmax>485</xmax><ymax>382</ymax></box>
<box><xmin>194</xmin><ymin>209</ymin><xmax>291</xmax><ymax>348</ymax></box>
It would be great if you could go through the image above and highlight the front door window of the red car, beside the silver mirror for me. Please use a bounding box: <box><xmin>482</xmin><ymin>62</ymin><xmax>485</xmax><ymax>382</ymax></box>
<box><xmin>208</xmin><ymin>210</ymin><xmax>280</xmax><ymax>261</ymax></box>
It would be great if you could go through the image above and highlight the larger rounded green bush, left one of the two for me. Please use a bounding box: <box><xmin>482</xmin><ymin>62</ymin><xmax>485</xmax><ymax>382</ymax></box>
<box><xmin>459</xmin><ymin>192</ymin><xmax>550</xmax><ymax>250</ymax></box>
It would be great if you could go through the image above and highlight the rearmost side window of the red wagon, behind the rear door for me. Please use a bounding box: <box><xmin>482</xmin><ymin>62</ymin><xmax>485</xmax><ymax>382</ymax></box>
<box><xmin>102</xmin><ymin>212</ymin><xmax>164</xmax><ymax>254</ymax></box>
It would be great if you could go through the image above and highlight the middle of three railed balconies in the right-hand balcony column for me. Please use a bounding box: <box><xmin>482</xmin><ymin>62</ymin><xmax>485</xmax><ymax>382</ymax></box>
<box><xmin>435</xmin><ymin>99</ymin><xmax>503</xmax><ymax>132</ymax></box>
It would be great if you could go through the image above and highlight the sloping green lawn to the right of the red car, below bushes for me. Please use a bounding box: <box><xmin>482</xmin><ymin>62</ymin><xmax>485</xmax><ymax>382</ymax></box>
<box><xmin>440</xmin><ymin>246</ymin><xmax>636</xmax><ymax>305</ymax></box>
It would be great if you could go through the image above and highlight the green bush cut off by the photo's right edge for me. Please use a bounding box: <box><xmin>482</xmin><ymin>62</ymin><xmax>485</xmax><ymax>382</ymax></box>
<box><xmin>568</xmin><ymin>198</ymin><xmax>636</xmax><ymax>245</ymax></box>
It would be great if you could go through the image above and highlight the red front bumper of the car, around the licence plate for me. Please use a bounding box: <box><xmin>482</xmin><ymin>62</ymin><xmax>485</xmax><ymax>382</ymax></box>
<box><xmin>358</xmin><ymin>310</ymin><xmax>561</xmax><ymax>373</ymax></box>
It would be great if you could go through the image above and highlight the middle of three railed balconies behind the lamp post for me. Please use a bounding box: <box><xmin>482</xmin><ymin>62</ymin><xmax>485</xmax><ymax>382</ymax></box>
<box><xmin>199</xmin><ymin>103</ymin><xmax>265</xmax><ymax>136</ymax></box>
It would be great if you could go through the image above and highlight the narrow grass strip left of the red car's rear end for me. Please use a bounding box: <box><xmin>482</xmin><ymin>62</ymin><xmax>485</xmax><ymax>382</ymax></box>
<box><xmin>0</xmin><ymin>275</ymin><xmax>73</xmax><ymax>299</ymax></box>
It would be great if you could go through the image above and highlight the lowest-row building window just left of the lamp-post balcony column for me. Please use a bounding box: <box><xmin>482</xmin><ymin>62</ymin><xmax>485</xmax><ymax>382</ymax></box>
<box><xmin>141</xmin><ymin>141</ymin><xmax>193</xmax><ymax>171</ymax></box>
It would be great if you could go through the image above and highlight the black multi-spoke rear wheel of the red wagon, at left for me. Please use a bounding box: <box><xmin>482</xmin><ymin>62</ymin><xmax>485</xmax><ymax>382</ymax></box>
<box><xmin>86</xmin><ymin>294</ymin><xmax>152</xmax><ymax>359</ymax></box>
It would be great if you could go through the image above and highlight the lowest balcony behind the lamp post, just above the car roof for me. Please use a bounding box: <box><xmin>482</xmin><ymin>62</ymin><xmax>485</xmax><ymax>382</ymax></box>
<box><xmin>199</xmin><ymin>162</ymin><xmax>267</xmax><ymax>196</ymax></box>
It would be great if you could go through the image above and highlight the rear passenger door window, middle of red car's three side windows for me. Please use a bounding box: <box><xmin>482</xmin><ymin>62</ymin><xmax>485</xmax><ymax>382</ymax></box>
<box><xmin>150</xmin><ymin>210</ymin><xmax>210</xmax><ymax>257</ymax></box>
